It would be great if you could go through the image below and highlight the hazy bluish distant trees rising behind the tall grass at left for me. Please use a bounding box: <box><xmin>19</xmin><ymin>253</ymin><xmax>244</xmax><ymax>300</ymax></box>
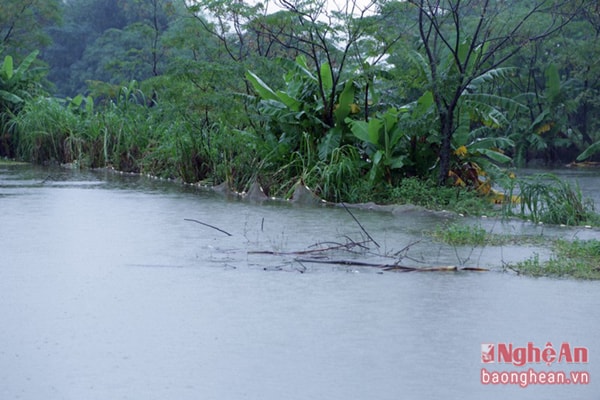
<box><xmin>42</xmin><ymin>0</ymin><xmax>184</xmax><ymax>96</ymax></box>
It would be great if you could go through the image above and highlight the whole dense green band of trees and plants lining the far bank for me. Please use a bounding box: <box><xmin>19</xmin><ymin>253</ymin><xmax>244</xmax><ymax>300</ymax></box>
<box><xmin>0</xmin><ymin>0</ymin><xmax>600</xmax><ymax>198</ymax></box>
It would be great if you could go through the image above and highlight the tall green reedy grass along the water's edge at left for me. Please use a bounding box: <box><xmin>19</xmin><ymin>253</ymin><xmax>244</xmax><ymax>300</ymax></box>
<box><xmin>11</xmin><ymin>90</ymin><xmax>260</xmax><ymax>190</ymax></box>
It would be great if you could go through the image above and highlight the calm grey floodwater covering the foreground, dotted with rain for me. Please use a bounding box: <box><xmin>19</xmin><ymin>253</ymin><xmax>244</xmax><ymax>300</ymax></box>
<box><xmin>0</xmin><ymin>165</ymin><xmax>600</xmax><ymax>400</ymax></box>
